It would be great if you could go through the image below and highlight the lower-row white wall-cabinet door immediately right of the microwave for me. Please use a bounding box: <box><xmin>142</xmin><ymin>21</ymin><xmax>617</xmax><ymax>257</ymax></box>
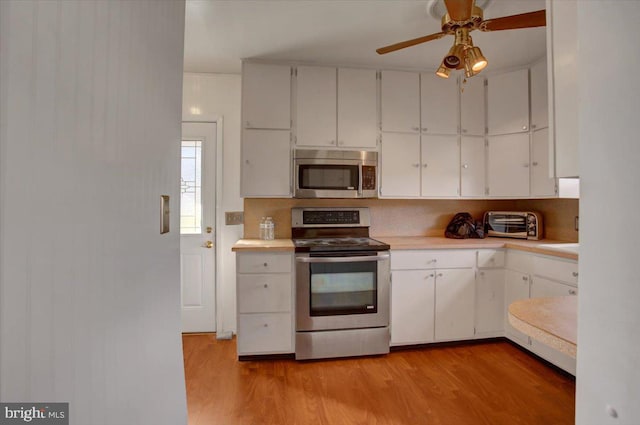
<box><xmin>380</xmin><ymin>133</ymin><xmax>420</xmax><ymax>197</ymax></box>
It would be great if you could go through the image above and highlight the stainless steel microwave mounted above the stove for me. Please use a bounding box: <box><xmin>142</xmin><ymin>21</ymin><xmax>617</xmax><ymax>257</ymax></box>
<box><xmin>293</xmin><ymin>149</ymin><xmax>378</xmax><ymax>198</ymax></box>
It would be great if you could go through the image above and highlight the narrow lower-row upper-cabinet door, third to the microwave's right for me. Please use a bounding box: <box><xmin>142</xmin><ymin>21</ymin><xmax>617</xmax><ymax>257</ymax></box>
<box><xmin>460</xmin><ymin>136</ymin><xmax>486</xmax><ymax>197</ymax></box>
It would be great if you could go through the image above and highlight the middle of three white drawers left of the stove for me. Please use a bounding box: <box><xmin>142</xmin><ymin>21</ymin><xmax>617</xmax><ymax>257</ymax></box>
<box><xmin>236</xmin><ymin>273</ymin><xmax>291</xmax><ymax>313</ymax></box>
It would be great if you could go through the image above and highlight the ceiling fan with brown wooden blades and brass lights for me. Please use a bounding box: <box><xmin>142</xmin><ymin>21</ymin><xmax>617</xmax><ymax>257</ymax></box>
<box><xmin>376</xmin><ymin>0</ymin><xmax>546</xmax><ymax>78</ymax></box>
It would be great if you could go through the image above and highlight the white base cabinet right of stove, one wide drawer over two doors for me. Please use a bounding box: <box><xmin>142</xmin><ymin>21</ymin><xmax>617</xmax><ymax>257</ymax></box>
<box><xmin>391</xmin><ymin>250</ymin><xmax>475</xmax><ymax>345</ymax></box>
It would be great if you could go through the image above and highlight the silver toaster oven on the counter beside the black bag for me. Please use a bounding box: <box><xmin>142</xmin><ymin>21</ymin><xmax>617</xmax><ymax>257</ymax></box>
<box><xmin>483</xmin><ymin>211</ymin><xmax>542</xmax><ymax>240</ymax></box>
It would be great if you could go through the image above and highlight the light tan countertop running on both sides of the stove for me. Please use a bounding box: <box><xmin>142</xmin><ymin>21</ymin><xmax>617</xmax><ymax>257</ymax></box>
<box><xmin>232</xmin><ymin>236</ymin><xmax>578</xmax><ymax>260</ymax></box>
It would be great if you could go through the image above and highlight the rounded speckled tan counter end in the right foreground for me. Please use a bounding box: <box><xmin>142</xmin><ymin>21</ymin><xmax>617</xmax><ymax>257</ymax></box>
<box><xmin>509</xmin><ymin>295</ymin><xmax>578</xmax><ymax>358</ymax></box>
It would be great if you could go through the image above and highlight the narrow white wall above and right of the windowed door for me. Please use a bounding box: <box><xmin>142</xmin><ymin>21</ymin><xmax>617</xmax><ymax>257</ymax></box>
<box><xmin>182</xmin><ymin>73</ymin><xmax>243</xmax><ymax>335</ymax></box>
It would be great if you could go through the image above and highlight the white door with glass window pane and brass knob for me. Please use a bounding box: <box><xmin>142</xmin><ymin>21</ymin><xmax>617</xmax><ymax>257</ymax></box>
<box><xmin>180</xmin><ymin>123</ymin><xmax>217</xmax><ymax>332</ymax></box>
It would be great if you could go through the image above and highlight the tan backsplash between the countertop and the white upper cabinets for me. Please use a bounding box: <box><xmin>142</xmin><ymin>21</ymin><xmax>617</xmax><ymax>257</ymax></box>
<box><xmin>244</xmin><ymin>198</ymin><xmax>579</xmax><ymax>242</ymax></box>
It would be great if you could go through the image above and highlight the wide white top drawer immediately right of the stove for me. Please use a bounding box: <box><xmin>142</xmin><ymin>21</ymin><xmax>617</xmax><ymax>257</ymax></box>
<box><xmin>391</xmin><ymin>250</ymin><xmax>476</xmax><ymax>270</ymax></box>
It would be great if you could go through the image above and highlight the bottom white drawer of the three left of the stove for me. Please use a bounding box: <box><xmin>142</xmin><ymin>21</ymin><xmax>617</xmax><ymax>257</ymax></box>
<box><xmin>237</xmin><ymin>313</ymin><xmax>293</xmax><ymax>355</ymax></box>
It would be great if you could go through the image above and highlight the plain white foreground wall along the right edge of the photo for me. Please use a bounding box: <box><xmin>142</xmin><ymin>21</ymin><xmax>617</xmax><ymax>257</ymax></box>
<box><xmin>576</xmin><ymin>0</ymin><xmax>640</xmax><ymax>425</ymax></box>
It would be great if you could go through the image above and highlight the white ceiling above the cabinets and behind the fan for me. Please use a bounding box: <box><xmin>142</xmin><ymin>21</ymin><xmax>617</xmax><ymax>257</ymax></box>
<box><xmin>184</xmin><ymin>0</ymin><xmax>546</xmax><ymax>73</ymax></box>
